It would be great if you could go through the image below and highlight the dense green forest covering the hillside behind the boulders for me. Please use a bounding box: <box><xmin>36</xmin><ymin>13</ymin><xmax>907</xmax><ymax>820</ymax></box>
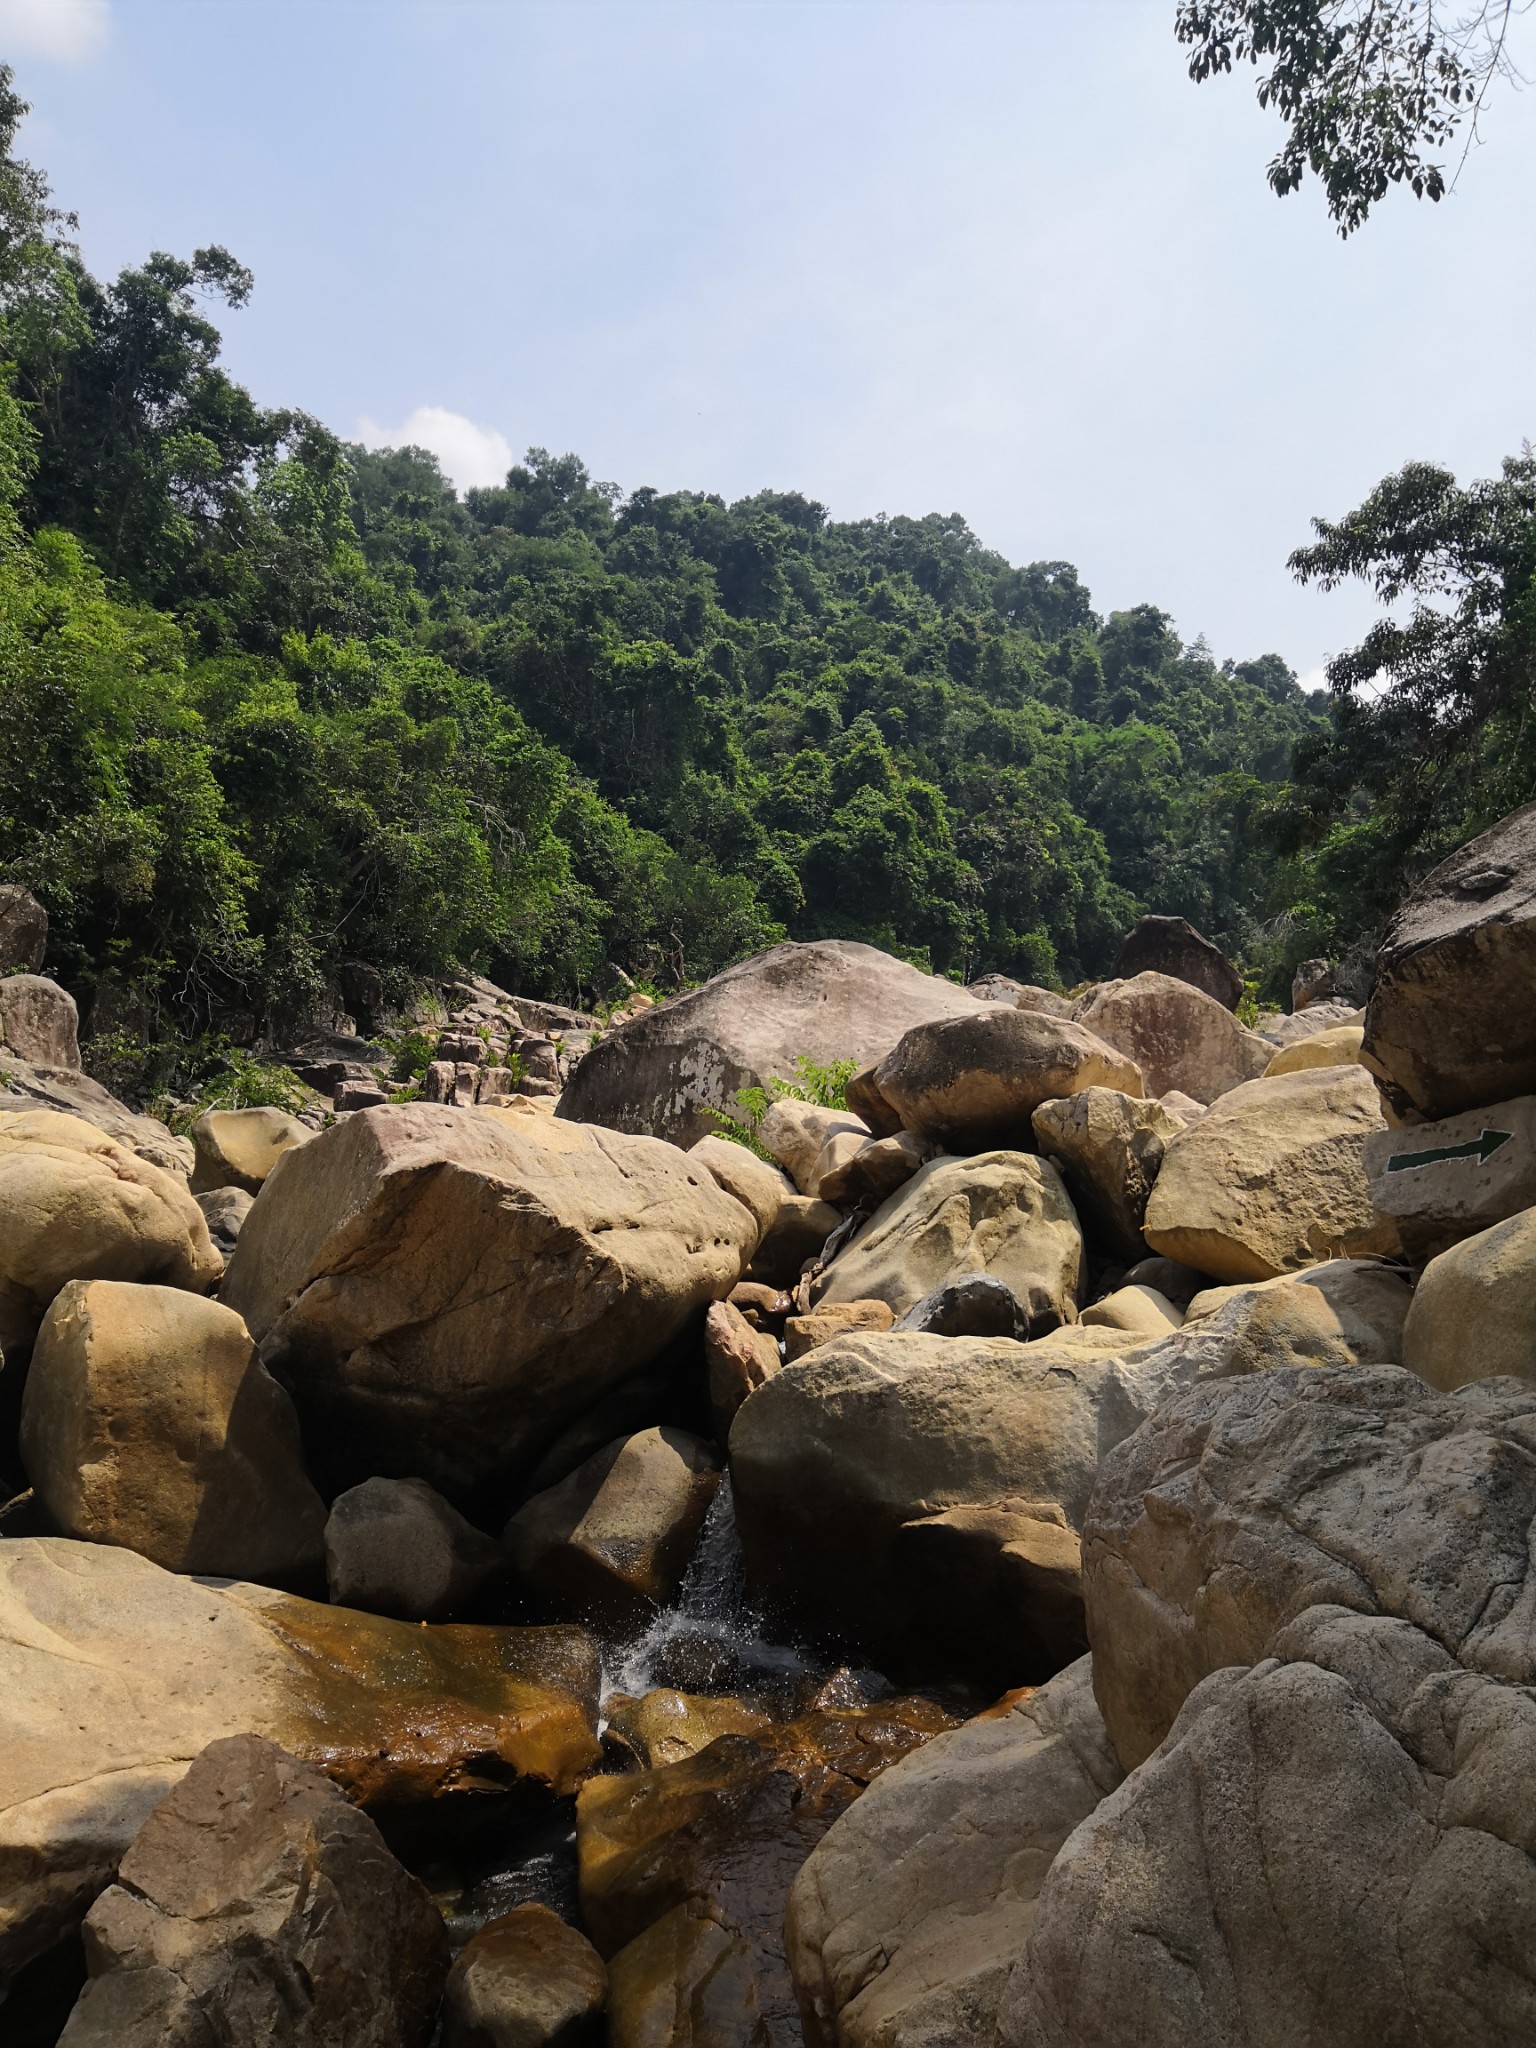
<box><xmin>0</xmin><ymin>74</ymin><xmax>1536</xmax><ymax>1081</ymax></box>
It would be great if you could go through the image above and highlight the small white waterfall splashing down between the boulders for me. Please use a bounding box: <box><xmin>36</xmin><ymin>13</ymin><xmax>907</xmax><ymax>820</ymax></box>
<box><xmin>602</xmin><ymin>1473</ymin><xmax>819</xmax><ymax>1700</ymax></box>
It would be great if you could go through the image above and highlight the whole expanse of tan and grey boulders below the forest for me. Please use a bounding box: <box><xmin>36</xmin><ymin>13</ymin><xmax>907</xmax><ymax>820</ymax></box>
<box><xmin>0</xmin><ymin>807</ymin><xmax>1536</xmax><ymax>2048</ymax></box>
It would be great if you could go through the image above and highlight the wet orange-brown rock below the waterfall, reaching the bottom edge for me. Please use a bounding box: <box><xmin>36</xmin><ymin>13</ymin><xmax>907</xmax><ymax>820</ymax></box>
<box><xmin>575</xmin><ymin>1700</ymin><xmax>954</xmax><ymax>2048</ymax></box>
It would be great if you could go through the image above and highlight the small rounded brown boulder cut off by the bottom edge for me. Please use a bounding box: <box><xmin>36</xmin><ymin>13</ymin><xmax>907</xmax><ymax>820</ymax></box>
<box><xmin>442</xmin><ymin>1905</ymin><xmax>608</xmax><ymax>2048</ymax></box>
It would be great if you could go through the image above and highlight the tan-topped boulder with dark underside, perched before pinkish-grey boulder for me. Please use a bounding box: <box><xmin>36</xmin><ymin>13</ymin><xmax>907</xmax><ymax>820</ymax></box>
<box><xmin>874</xmin><ymin>1008</ymin><xmax>1143</xmax><ymax>1153</ymax></box>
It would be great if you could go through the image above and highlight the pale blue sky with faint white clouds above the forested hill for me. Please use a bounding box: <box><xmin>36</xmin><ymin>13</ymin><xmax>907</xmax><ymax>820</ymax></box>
<box><xmin>0</xmin><ymin>0</ymin><xmax>1536</xmax><ymax>682</ymax></box>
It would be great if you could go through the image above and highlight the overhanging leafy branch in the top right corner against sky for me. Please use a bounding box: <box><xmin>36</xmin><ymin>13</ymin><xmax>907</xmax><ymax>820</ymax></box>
<box><xmin>1174</xmin><ymin>0</ymin><xmax>1530</xmax><ymax>236</ymax></box>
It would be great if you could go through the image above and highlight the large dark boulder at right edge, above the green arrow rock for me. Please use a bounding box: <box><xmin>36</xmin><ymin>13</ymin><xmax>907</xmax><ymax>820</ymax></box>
<box><xmin>1362</xmin><ymin>803</ymin><xmax>1536</xmax><ymax>1120</ymax></box>
